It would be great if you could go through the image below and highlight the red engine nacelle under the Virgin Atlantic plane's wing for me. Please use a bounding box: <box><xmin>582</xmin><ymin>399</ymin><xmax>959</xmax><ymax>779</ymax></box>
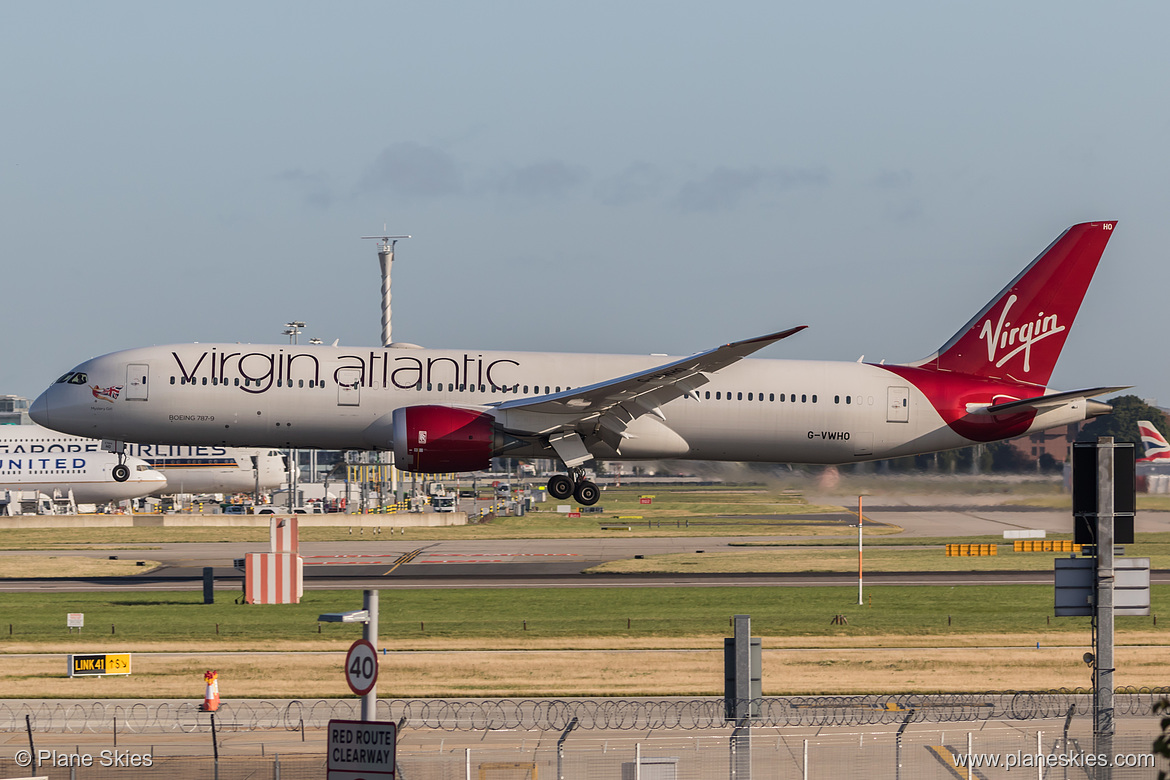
<box><xmin>394</xmin><ymin>406</ymin><xmax>495</xmax><ymax>474</ymax></box>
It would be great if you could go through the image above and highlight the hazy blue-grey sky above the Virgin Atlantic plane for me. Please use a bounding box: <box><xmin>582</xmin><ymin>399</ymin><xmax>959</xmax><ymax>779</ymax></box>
<box><xmin>0</xmin><ymin>0</ymin><xmax>1170</xmax><ymax>406</ymax></box>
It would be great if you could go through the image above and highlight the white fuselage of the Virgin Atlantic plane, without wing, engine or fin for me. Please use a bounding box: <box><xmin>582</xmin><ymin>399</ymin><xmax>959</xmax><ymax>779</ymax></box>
<box><xmin>25</xmin><ymin>344</ymin><xmax>1085</xmax><ymax>463</ymax></box>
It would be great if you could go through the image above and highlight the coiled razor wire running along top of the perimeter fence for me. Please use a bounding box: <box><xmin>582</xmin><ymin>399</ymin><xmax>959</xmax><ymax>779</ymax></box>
<box><xmin>0</xmin><ymin>688</ymin><xmax>1170</xmax><ymax>733</ymax></box>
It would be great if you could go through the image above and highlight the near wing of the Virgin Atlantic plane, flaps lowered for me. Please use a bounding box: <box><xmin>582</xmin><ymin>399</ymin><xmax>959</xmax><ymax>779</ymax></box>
<box><xmin>494</xmin><ymin>325</ymin><xmax>807</xmax><ymax>465</ymax></box>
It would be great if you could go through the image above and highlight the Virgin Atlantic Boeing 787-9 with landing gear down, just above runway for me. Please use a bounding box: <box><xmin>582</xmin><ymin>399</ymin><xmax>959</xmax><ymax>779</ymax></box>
<box><xmin>29</xmin><ymin>222</ymin><xmax>1120</xmax><ymax>505</ymax></box>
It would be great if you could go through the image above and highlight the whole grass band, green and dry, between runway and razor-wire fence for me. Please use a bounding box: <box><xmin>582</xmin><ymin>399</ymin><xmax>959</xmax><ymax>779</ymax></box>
<box><xmin>0</xmin><ymin>586</ymin><xmax>1170</xmax><ymax>698</ymax></box>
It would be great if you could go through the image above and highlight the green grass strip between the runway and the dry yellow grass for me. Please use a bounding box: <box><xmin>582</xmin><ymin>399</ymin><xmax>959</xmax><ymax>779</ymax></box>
<box><xmin>0</xmin><ymin>585</ymin><xmax>1170</xmax><ymax>651</ymax></box>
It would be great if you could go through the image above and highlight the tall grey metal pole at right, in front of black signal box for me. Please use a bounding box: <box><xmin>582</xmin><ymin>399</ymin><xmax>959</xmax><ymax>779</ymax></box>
<box><xmin>1093</xmin><ymin>436</ymin><xmax>1115</xmax><ymax>780</ymax></box>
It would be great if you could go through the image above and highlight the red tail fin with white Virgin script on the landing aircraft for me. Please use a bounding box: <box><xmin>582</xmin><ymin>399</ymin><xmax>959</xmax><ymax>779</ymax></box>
<box><xmin>914</xmin><ymin>221</ymin><xmax>1116</xmax><ymax>386</ymax></box>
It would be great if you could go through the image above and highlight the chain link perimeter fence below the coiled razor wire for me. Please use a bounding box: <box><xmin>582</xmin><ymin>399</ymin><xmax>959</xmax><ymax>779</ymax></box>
<box><xmin>0</xmin><ymin>718</ymin><xmax>1168</xmax><ymax>780</ymax></box>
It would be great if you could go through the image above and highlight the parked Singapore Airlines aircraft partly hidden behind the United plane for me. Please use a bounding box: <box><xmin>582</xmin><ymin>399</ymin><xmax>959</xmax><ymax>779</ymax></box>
<box><xmin>0</xmin><ymin>426</ymin><xmax>284</xmax><ymax>496</ymax></box>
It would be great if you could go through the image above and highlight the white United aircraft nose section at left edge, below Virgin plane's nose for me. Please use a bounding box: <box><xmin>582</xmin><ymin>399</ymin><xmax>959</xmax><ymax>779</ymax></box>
<box><xmin>0</xmin><ymin>444</ymin><xmax>166</xmax><ymax>504</ymax></box>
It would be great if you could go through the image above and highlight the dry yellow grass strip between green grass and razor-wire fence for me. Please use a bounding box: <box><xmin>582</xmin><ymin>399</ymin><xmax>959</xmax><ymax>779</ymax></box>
<box><xmin>0</xmin><ymin>640</ymin><xmax>1170</xmax><ymax>699</ymax></box>
